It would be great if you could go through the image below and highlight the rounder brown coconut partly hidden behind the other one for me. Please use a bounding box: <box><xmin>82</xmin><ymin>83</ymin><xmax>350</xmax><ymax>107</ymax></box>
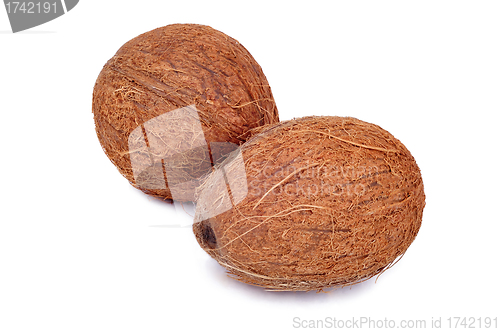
<box><xmin>92</xmin><ymin>24</ymin><xmax>279</xmax><ymax>201</ymax></box>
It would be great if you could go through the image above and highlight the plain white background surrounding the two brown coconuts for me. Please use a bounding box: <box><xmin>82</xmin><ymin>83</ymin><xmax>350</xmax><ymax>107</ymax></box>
<box><xmin>0</xmin><ymin>0</ymin><xmax>500</xmax><ymax>332</ymax></box>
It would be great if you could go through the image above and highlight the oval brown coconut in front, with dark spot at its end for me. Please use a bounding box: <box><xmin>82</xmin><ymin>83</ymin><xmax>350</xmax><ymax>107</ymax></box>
<box><xmin>193</xmin><ymin>116</ymin><xmax>425</xmax><ymax>291</ymax></box>
